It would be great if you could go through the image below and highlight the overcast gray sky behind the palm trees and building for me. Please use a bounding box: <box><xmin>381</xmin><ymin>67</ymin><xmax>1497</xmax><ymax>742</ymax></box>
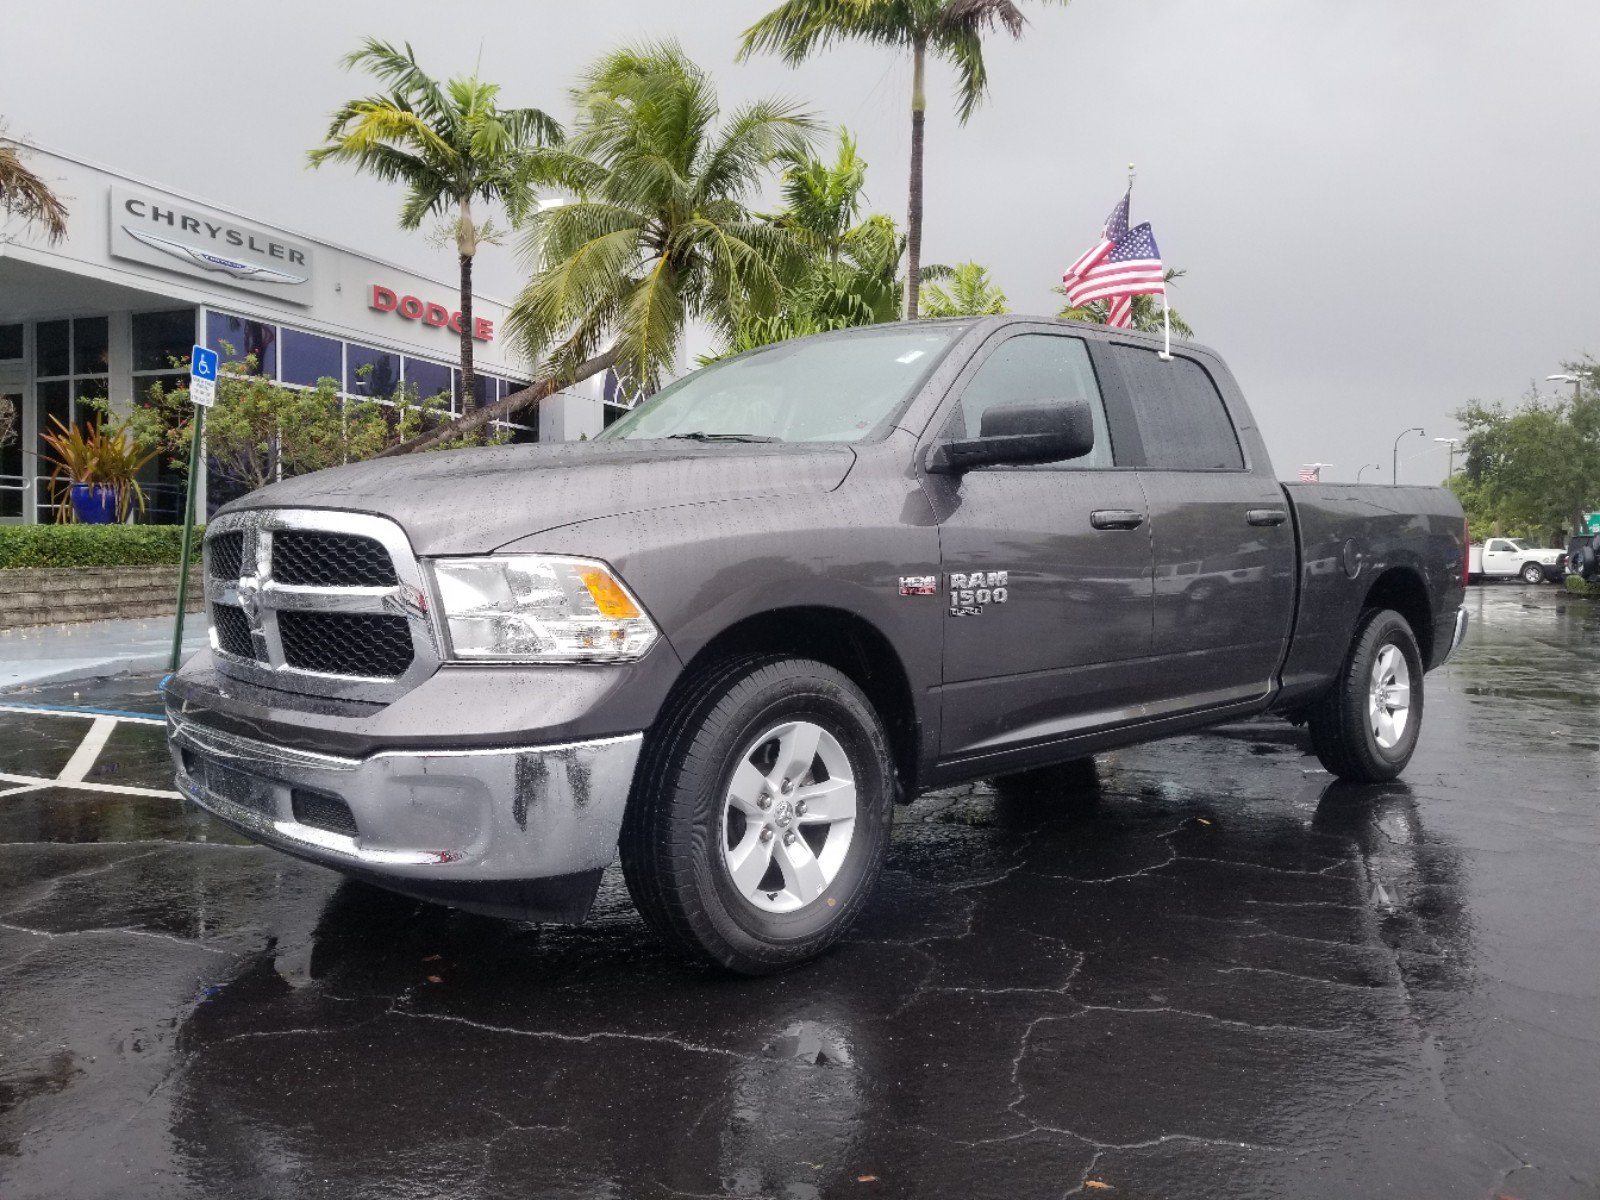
<box><xmin>0</xmin><ymin>0</ymin><xmax>1600</xmax><ymax>482</ymax></box>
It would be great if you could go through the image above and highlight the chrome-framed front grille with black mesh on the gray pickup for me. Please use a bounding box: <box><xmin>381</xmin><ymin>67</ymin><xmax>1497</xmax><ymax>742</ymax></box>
<box><xmin>205</xmin><ymin>509</ymin><xmax>440</xmax><ymax>701</ymax></box>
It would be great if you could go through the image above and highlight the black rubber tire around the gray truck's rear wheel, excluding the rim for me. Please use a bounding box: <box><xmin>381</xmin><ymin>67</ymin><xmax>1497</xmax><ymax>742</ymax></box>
<box><xmin>1307</xmin><ymin>608</ymin><xmax>1422</xmax><ymax>784</ymax></box>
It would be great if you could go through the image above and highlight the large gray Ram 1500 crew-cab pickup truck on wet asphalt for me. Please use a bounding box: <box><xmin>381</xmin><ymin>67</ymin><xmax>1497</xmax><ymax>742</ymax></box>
<box><xmin>166</xmin><ymin>317</ymin><xmax>1467</xmax><ymax>973</ymax></box>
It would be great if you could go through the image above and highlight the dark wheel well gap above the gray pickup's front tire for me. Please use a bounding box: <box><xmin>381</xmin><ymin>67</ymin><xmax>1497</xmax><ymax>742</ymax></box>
<box><xmin>683</xmin><ymin>606</ymin><xmax>918</xmax><ymax>802</ymax></box>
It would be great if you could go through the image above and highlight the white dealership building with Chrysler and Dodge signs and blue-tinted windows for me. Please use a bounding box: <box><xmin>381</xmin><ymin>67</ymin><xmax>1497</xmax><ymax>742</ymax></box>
<box><xmin>0</xmin><ymin>138</ymin><xmax>624</xmax><ymax>523</ymax></box>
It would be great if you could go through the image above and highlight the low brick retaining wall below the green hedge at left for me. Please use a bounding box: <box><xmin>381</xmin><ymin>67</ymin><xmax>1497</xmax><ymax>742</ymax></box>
<box><xmin>0</xmin><ymin>563</ymin><xmax>205</xmax><ymax>629</ymax></box>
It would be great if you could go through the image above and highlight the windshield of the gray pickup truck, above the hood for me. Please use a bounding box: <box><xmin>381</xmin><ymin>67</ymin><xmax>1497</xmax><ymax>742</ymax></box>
<box><xmin>600</xmin><ymin>323</ymin><xmax>966</xmax><ymax>442</ymax></box>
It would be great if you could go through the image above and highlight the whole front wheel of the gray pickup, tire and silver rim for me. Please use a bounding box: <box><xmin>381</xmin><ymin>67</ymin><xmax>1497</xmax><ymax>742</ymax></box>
<box><xmin>621</xmin><ymin>656</ymin><xmax>894</xmax><ymax>974</ymax></box>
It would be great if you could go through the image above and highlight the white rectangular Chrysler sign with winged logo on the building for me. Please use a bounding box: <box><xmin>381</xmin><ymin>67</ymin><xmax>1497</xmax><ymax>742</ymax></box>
<box><xmin>110</xmin><ymin>186</ymin><xmax>312</xmax><ymax>304</ymax></box>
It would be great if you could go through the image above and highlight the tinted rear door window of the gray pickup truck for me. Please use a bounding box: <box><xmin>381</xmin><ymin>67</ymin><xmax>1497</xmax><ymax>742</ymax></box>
<box><xmin>1112</xmin><ymin>346</ymin><xmax>1245</xmax><ymax>470</ymax></box>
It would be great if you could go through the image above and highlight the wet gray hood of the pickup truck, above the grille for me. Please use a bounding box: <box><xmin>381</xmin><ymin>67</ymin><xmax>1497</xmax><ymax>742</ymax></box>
<box><xmin>221</xmin><ymin>442</ymin><xmax>856</xmax><ymax>555</ymax></box>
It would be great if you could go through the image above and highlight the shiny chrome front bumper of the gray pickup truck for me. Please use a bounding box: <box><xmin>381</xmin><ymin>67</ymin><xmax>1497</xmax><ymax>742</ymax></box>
<box><xmin>166</xmin><ymin>709</ymin><xmax>643</xmax><ymax>907</ymax></box>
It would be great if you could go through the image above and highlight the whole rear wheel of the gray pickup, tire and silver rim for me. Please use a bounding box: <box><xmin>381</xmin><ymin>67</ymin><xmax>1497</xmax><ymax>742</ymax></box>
<box><xmin>1307</xmin><ymin>608</ymin><xmax>1422</xmax><ymax>782</ymax></box>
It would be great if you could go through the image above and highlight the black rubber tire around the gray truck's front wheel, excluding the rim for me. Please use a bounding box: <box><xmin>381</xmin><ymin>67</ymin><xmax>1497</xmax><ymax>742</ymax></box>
<box><xmin>621</xmin><ymin>656</ymin><xmax>894</xmax><ymax>974</ymax></box>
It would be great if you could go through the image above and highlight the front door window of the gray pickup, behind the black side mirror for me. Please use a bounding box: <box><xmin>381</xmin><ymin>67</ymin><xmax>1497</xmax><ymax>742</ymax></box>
<box><xmin>962</xmin><ymin>333</ymin><xmax>1112</xmax><ymax>469</ymax></box>
